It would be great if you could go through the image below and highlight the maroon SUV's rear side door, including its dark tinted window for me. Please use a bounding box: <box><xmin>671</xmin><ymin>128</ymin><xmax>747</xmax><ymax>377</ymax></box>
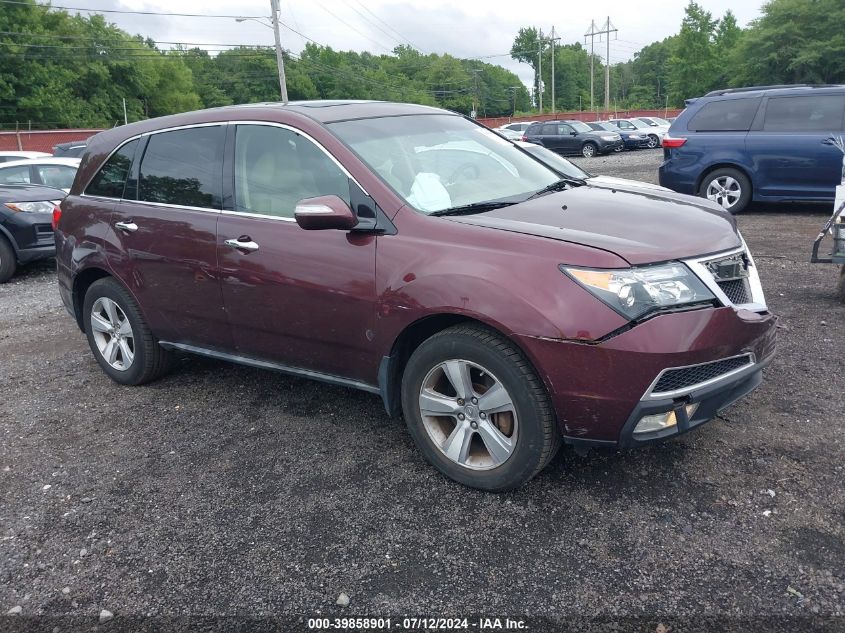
<box><xmin>109</xmin><ymin>123</ymin><xmax>231</xmax><ymax>349</ymax></box>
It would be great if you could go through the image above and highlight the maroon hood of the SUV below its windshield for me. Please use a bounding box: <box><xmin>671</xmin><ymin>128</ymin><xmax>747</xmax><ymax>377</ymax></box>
<box><xmin>446</xmin><ymin>185</ymin><xmax>741</xmax><ymax>265</ymax></box>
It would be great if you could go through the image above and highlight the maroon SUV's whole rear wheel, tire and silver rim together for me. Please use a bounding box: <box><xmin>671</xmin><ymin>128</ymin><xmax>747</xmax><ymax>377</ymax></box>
<box><xmin>82</xmin><ymin>277</ymin><xmax>172</xmax><ymax>385</ymax></box>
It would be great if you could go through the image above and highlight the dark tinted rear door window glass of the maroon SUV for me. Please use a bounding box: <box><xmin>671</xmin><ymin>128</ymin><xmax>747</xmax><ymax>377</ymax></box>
<box><xmin>138</xmin><ymin>125</ymin><xmax>225</xmax><ymax>209</ymax></box>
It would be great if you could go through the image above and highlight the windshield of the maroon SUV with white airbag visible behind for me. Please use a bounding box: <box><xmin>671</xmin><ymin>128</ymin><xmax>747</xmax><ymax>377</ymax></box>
<box><xmin>329</xmin><ymin>114</ymin><xmax>559</xmax><ymax>213</ymax></box>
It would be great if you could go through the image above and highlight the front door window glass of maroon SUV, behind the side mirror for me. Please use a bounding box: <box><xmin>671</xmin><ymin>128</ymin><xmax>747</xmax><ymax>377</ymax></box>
<box><xmin>235</xmin><ymin>125</ymin><xmax>349</xmax><ymax>218</ymax></box>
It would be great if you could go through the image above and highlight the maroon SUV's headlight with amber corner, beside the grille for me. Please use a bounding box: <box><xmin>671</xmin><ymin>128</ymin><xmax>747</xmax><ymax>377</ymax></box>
<box><xmin>560</xmin><ymin>263</ymin><xmax>715</xmax><ymax>321</ymax></box>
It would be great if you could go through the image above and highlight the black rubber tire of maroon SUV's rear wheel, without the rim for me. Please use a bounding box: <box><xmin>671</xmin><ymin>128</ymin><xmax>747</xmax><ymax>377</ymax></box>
<box><xmin>82</xmin><ymin>277</ymin><xmax>172</xmax><ymax>385</ymax></box>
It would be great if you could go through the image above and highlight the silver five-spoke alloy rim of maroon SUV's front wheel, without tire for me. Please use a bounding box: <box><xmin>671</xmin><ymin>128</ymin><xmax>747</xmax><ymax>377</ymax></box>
<box><xmin>419</xmin><ymin>359</ymin><xmax>519</xmax><ymax>470</ymax></box>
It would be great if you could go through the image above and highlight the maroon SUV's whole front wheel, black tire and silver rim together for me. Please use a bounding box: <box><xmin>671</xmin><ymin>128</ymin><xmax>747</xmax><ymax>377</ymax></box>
<box><xmin>402</xmin><ymin>325</ymin><xmax>560</xmax><ymax>491</ymax></box>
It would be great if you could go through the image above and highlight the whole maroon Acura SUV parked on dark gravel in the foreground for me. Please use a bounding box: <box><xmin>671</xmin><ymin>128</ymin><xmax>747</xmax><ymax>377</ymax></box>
<box><xmin>56</xmin><ymin>101</ymin><xmax>775</xmax><ymax>490</ymax></box>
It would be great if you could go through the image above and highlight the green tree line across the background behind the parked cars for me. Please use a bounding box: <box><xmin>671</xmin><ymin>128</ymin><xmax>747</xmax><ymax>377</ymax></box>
<box><xmin>0</xmin><ymin>0</ymin><xmax>845</xmax><ymax>128</ymax></box>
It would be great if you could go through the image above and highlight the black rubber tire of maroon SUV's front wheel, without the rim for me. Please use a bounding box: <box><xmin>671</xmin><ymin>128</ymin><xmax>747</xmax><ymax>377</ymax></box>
<box><xmin>402</xmin><ymin>325</ymin><xmax>561</xmax><ymax>492</ymax></box>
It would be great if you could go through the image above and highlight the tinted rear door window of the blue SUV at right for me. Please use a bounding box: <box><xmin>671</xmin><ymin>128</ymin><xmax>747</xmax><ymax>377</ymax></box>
<box><xmin>763</xmin><ymin>95</ymin><xmax>845</xmax><ymax>132</ymax></box>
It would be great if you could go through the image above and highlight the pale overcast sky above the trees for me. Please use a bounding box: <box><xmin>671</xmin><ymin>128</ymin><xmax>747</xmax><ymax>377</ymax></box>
<box><xmin>69</xmin><ymin>0</ymin><xmax>763</xmax><ymax>89</ymax></box>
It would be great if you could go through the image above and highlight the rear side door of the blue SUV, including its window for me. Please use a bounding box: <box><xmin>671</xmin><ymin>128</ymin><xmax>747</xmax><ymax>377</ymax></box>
<box><xmin>746</xmin><ymin>94</ymin><xmax>845</xmax><ymax>200</ymax></box>
